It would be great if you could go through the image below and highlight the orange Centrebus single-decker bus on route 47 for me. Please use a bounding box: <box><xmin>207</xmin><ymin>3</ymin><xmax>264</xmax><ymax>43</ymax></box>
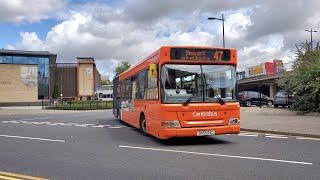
<box><xmin>113</xmin><ymin>46</ymin><xmax>240</xmax><ymax>139</ymax></box>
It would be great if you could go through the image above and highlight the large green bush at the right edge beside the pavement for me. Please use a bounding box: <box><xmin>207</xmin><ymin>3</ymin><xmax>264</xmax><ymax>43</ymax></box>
<box><xmin>280</xmin><ymin>43</ymin><xmax>320</xmax><ymax>112</ymax></box>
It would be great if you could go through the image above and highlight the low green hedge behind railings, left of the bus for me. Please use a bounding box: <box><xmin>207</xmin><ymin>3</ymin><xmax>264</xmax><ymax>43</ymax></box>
<box><xmin>47</xmin><ymin>100</ymin><xmax>113</xmax><ymax>110</ymax></box>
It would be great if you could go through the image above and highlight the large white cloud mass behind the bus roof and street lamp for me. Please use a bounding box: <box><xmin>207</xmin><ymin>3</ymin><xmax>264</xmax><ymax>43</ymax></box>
<box><xmin>8</xmin><ymin>0</ymin><xmax>319</xmax><ymax>76</ymax></box>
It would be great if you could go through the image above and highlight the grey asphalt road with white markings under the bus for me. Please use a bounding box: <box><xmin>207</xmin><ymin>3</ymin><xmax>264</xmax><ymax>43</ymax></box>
<box><xmin>0</xmin><ymin>111</ymin><xmax>320</xmax><ymax>180</ymax></box>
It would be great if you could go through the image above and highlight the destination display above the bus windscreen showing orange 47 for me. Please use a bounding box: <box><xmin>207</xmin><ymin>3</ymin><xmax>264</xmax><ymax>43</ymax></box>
<box><xmin>170</xmin><ymin>48</ymin><xmax>231</xmax><ymax>62</ymax></box>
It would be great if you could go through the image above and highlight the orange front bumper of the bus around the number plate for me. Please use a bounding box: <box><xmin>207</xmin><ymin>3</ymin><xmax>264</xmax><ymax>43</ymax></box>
<box><xmin>158</xmin><ymin>125</ymin><xmax>240</xmax><ymax>139</ymax></box>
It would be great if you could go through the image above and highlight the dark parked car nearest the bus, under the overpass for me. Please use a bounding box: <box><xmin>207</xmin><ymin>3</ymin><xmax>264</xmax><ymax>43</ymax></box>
<box><xmin>238</xmin><ymin>91</ymin><xmax>273</xmax><ymax>107</ymax></box>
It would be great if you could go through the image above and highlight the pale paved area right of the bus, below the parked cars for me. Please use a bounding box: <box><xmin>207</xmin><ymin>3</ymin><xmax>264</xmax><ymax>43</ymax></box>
<box><xmin>240</xmin><ymin>107</ymin><xmax>320</xmax><ymax>138</ymax></box>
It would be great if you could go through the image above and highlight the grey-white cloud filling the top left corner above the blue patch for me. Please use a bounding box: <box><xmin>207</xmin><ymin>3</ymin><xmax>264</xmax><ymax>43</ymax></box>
<box><xmin>0</xmin><ymin>0</ymin><xmax>66</xmax><ymax>23</ymax></box>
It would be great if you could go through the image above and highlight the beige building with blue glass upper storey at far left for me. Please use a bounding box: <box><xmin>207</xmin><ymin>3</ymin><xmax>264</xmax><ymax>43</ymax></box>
<box><xmin>0</xmin><ymin>49</ymin><xmax>57</xmax><ymax>102</ymax></box>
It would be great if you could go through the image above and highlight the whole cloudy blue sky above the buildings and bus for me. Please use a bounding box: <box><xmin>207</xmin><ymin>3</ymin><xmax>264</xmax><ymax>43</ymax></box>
<box><xmin>0</xmin><ymin>0</ymin><xmax>320</xmax><ymax>77</ymax></box>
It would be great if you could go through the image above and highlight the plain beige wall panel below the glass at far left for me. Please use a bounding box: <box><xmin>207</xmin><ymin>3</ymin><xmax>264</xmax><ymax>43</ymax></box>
<box><xmin>0</xmin><ymin>64</ymin><xmax>38</xmax><ymax>102</ymax></box>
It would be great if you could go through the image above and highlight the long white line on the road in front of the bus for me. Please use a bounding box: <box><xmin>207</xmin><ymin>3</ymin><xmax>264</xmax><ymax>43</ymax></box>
<box><xmin>119</xmin><ymin>145</ymin><xmax>312</xmax><ymax>165</ymax></box>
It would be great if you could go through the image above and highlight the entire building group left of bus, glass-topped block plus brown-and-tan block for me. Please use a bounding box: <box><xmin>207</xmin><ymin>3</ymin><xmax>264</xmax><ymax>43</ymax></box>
<box><xmin>0</xmin><ymin>49</ymin><xmax>101</xmax><ymax>105</ymax></box>
